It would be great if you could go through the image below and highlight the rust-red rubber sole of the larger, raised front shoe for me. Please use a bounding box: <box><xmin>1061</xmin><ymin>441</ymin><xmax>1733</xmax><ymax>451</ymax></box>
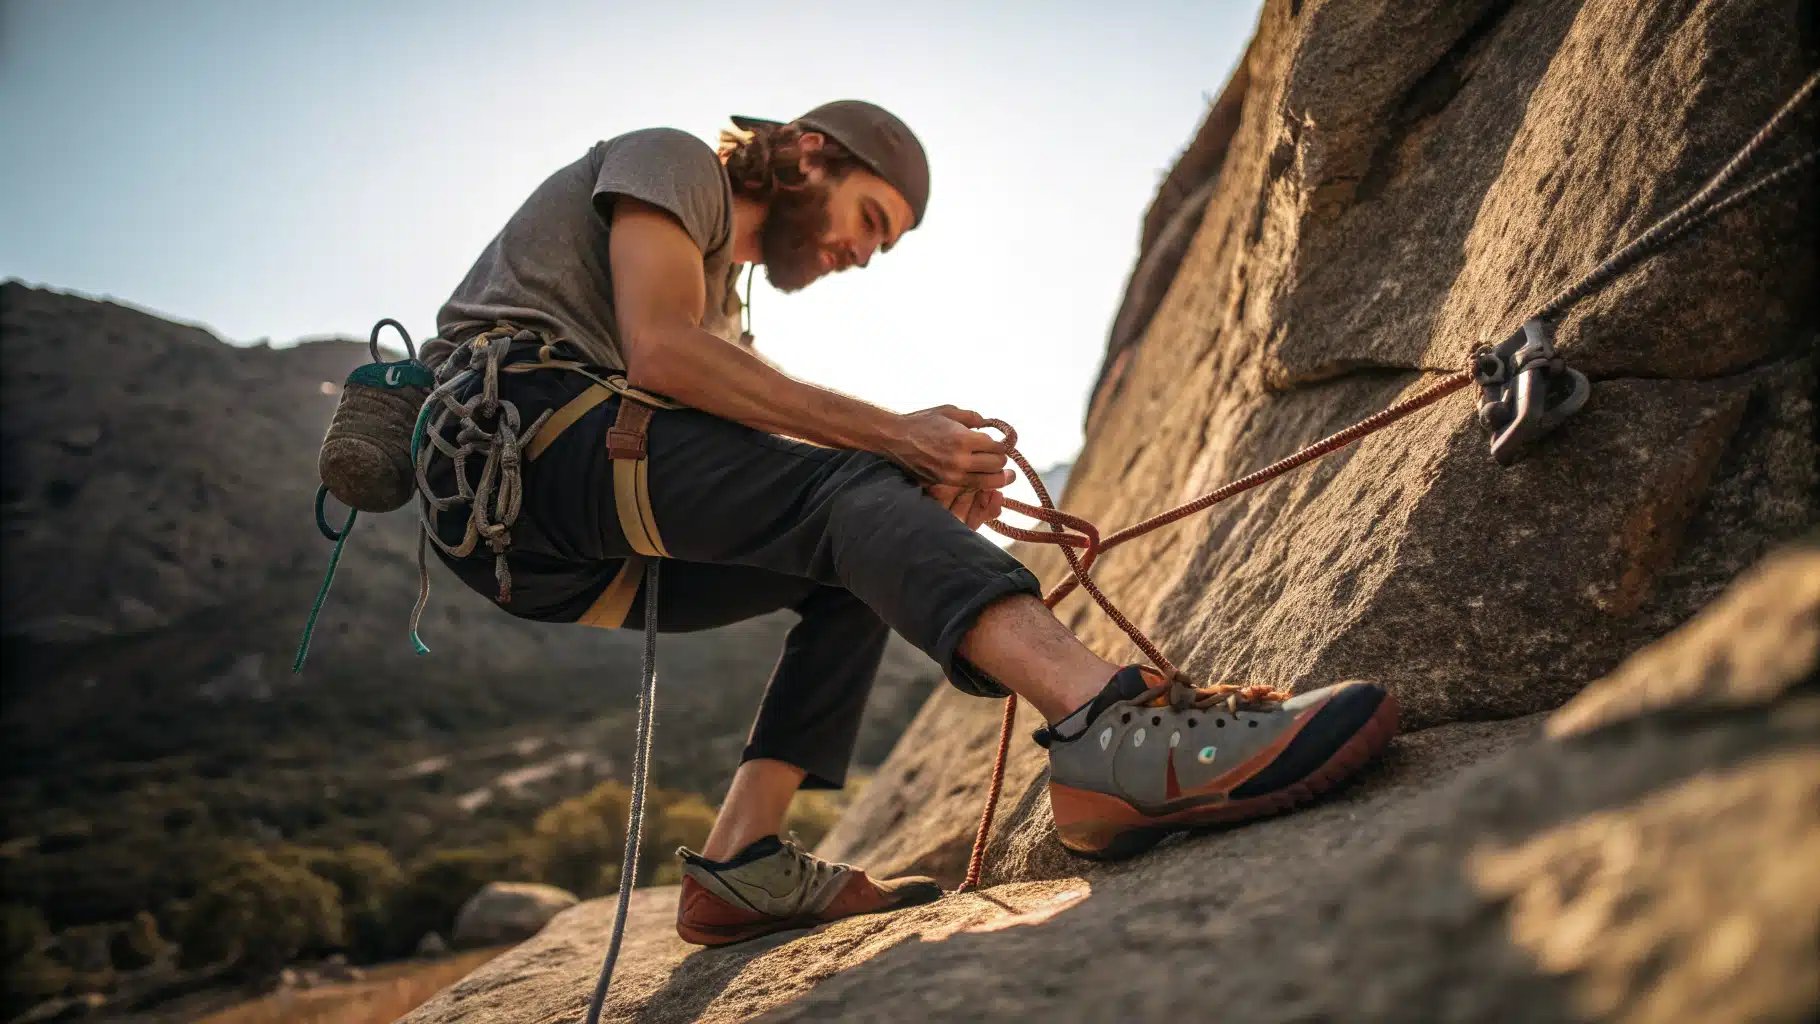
<box><xmin>1048</xmin><ymin>693</ymin><xmax>1398</xmax><ymax>860</ymax></box>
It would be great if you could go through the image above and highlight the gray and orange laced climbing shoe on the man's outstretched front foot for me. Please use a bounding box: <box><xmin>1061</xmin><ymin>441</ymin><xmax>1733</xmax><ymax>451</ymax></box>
<box><xmin>1036</xmin><ymin>666</ymin><xmax>1396</xmax><ymax>860</ymax></box>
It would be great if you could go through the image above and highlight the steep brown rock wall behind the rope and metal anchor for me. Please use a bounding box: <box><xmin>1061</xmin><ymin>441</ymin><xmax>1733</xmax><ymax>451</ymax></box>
<box><xmin>826</xmin><ymin>0</ymin><xmax>1820</xmax><ymax>882</ymax></box>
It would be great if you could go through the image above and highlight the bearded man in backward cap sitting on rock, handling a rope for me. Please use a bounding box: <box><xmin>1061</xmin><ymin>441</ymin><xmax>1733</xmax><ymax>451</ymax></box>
<box><xmin>426</xmin><ymin>100</ymin><xmax>1394</xmax><ymax>944</ymax></box>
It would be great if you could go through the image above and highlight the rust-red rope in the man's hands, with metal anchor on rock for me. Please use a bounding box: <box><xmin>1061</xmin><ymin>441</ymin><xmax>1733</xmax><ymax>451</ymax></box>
<box><xmin>957</xmin><ymin>73</ymin><xmax>1820</xmax><ymax>891</ymax></box>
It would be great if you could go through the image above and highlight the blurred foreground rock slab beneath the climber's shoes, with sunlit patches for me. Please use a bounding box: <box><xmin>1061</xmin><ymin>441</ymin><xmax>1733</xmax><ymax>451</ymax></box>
<box><xmin>408</xmin><ymin>533</ymin><xmax>1820</xmax><ymax>1024</ymax></box>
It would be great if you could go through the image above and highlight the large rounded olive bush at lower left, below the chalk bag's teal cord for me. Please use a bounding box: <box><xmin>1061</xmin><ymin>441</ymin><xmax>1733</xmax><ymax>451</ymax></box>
<box><xmin>182</xmin><ymin>851</ymin><xmax>342</xmax><ymax>977</ymax></box>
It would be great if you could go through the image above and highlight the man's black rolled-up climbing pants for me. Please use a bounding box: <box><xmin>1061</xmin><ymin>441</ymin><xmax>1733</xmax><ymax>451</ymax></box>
<box><xmin>431</xmin><ymin>349</ymin><xmax>1041</xmax><ymax>788</ymax></box>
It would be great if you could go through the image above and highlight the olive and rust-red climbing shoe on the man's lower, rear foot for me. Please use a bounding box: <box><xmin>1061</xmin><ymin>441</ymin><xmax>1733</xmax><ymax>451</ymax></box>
<box><xmin>677</xmin><ymin>835</ymin><xmax>941</xmax><ymax>946</ymax></box>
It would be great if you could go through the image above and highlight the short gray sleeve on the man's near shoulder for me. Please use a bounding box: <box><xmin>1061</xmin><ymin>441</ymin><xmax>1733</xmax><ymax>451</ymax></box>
<box><xmin>593</xmin><ymin>127</ymin><xmax>732</xmax><ymax>253</ymax></box>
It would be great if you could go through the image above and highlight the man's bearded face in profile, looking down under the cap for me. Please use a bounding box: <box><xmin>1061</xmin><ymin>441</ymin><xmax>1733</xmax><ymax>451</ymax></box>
<box><xmin>761</xmin><ymin>133</ymin><xmax>912</xmax><ymax>291</ymax></box>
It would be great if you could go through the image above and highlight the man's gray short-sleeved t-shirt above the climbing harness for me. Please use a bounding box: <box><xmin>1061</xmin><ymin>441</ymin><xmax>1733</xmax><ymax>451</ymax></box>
<box><xmin>426</xmin><ymin>127</ymin><xmax>739</xmax><ymax>369</ymax></box>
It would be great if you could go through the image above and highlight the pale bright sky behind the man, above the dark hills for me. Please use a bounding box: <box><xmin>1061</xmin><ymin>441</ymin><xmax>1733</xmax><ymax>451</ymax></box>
<box><xmin>0</xmin><ymin>0</ymin><xmax>1258</xmax><ymax>480</ymax></box>
